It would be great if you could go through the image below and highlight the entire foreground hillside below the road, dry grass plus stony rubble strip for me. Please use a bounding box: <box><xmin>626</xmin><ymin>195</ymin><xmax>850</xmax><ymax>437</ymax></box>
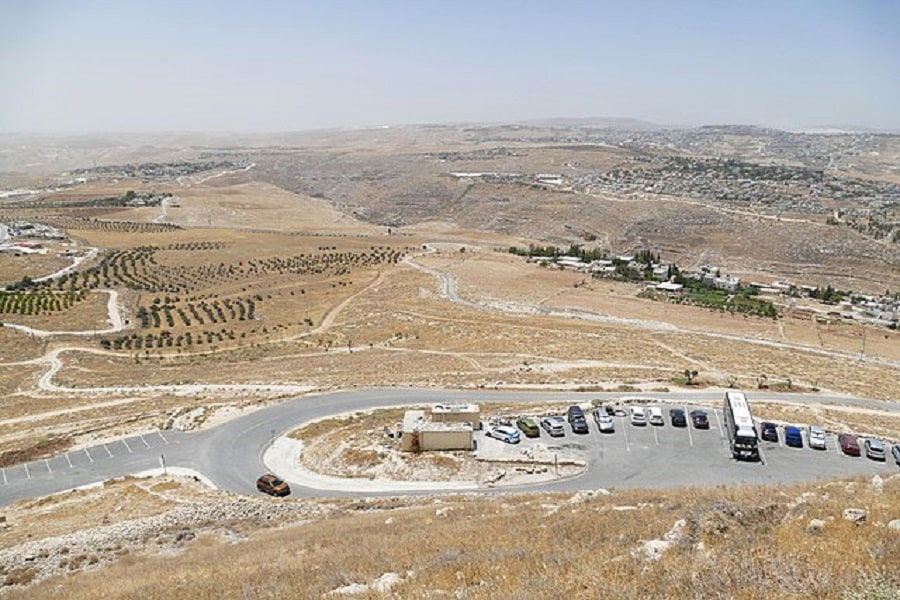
<box><xmin>0</xmin><ymin>475</ymin><xmax>900</xmax><ymax>600</ymax></box>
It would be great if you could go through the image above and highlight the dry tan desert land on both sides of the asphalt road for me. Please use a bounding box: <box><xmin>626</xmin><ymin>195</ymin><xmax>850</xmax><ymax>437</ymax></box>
<box><xmin>0</xmin><ymin>124</ymin><xmax>900</xmax><ymax>598</ymax></box>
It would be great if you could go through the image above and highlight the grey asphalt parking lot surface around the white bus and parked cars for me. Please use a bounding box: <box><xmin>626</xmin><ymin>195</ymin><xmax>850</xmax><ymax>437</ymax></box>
<box><xmin>478</xmin><ymin>403</ymin><xmax>900</xmax><ymax>489</ymax></box>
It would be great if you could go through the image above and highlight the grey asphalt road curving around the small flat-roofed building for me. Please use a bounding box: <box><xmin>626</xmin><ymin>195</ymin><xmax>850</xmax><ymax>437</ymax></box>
<box><xmin>0</xmin><ymin>388</ymin><xmax>900</xmax><ymax>506</ymax></box>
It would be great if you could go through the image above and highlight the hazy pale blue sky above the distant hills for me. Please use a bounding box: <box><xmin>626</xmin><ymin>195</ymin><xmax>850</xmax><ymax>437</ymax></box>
<box><xmin>0</xmin><ymin>0</ymin><xmax>900</xmax><ymax>132</ymax></box>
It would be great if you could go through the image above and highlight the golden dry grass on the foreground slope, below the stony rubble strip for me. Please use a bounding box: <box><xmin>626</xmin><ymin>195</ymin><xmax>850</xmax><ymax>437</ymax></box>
<box><xmin>9</xmin><ymin>477</ymin><xmax>900</xmax><ymax>600</ymax></box>
